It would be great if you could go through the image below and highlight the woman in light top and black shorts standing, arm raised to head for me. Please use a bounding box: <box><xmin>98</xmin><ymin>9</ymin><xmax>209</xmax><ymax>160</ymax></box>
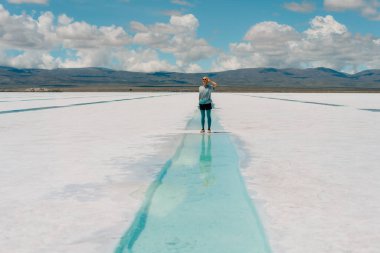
<box><xmin>199</xmin><ymin>76</ymin><xmax>218</xmax><ymax>133</ymax></box>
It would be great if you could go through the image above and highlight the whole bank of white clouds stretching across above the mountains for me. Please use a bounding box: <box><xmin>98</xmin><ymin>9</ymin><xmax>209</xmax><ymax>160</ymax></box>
<box><xmin>0</xmin><ymin>4</ymin><xmax>380</xmax><ymax>72</ymax></box>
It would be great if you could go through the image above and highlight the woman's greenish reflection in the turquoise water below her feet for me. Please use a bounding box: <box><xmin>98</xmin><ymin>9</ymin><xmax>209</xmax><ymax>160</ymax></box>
<box><xmin>199</xmin><ymin>135</ymin><xmax>215</xmax><ymax>187</ymax></box>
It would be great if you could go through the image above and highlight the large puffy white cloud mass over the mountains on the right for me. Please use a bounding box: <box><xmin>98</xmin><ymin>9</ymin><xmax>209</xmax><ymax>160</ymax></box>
<box><xmin>213</xmin><ymin>15</ymin><xmax>380</xmax><ymax>72</ymax></box>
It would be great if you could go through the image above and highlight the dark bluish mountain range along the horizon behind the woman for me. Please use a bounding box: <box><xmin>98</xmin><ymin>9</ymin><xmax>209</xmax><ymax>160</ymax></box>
<box><xmin>0</xmin><ymin>67</ymin><xmax>380</xmax><ymax>91</ymax></box>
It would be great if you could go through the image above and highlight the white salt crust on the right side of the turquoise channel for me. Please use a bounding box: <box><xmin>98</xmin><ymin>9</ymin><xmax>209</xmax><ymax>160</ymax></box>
<box><xmin>215</xmin><ymin>94</ymin><xmax>380</xmax><ymax>253</ymax></box>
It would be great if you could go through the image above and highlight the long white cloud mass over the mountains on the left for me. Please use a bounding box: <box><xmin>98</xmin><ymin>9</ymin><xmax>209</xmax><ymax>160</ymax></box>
<box><xmin>0</xmin><ymin>4</ymin><xmax>208</xmax><ymax>72</ymax></box>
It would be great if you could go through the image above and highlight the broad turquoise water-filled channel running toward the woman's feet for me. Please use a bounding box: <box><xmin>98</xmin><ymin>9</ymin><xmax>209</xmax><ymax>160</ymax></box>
<box><xmin>115</xmin><ymin>111</ymin><xmax>270</xmax><ymax>253</ymax></box>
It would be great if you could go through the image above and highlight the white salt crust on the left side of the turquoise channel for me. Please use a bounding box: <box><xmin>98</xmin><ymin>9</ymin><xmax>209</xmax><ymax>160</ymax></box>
<box><xmin>0</xmin><ymin>93</ymin><xmax>196</xmax><ymax>253</ymax></box>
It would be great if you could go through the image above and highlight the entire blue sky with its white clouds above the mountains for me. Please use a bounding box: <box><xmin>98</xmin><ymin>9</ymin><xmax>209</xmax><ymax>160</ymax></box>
<box><xmin>0</xmin><ymin>0</ymin><xmax>380</xmax><ymax>72</ymax></box>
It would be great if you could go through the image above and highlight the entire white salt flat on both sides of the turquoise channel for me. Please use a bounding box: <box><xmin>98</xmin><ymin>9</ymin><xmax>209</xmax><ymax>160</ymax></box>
<box><xmin>0</xmin><ymin>93</ymin><xmax>380</xmax><ymax>253</ymax></box>
